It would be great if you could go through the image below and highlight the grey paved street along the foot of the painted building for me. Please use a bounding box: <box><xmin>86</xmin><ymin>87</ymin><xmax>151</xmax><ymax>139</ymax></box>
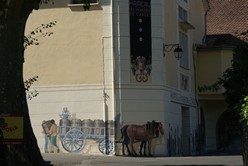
<box><xmin>42</xmin><ymin>153</ymin><xmax>243</xmax><ymax>166</ymax></box>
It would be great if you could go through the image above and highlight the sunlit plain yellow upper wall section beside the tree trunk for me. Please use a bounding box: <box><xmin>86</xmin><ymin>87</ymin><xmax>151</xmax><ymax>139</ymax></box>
<box><xmin>24</xmin><ymin>0</ymin><xmax>103</xmax><ymax>86</ymax></box>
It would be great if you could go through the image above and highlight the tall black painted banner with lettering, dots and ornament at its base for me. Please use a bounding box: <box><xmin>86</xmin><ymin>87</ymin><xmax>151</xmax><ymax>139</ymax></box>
<box><xmin>129</xmin><ymin>0</ymin><xmax>152</xmax><ymax>83</ymax></box>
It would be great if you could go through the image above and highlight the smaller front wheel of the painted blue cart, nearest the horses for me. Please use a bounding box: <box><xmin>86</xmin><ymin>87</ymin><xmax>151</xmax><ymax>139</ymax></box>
<box><xmin>98</xmin><ymin>139</ymin><xmax>115</xmax><ymax>154</ymax></box>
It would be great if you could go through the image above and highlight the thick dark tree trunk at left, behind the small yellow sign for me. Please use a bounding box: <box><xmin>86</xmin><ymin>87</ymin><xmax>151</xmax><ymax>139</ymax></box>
<box><xmin>0</xmin><ymin>0</ymin><xmax>45</xmax><ymax>166</ymax></box>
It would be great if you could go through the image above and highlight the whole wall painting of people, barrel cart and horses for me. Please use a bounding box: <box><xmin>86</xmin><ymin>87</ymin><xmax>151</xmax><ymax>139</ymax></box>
<box><xmin>41</xmin><ymin>107</ymin><xmax>164</xmax><ymax>156</ymax></box>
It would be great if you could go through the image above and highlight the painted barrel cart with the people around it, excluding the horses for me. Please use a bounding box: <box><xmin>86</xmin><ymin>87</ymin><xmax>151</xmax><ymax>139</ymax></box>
<box><xmin>42</xmin><ymin>107</ymin><xmax>115</xmax><ymax>154</ymax></box>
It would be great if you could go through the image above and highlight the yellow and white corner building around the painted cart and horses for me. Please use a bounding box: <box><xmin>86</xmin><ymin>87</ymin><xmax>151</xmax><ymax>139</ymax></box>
<box><xmin>25</xmin><ymin>0</ymin><xmax>206</xmax><ymax>156</ymax></box>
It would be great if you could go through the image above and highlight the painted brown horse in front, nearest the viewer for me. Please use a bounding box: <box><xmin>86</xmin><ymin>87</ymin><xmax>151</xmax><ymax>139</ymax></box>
<box><xmin>126</xmin><ymin>121</ymin><xmax>164</xmax><ymax>156</ymax></box>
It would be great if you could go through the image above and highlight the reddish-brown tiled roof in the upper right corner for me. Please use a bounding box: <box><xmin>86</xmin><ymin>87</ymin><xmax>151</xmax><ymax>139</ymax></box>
<box><xmin>207</xmin><ymin>0</ymin><xmax>248</xmax><ymax>37</ymax></box>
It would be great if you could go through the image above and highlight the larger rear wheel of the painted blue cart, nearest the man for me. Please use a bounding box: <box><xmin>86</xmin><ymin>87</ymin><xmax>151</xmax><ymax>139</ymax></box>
<box><xmin>61</xmin><ymin>129</ymin><xmax>86</xmax><ymax>152</ymax></box>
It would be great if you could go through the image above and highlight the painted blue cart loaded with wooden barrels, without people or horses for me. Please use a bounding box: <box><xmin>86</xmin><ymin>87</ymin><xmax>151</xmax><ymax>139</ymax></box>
<box><xmin>58</xmin><ymin>119</ymin><xmax>115</xmax><ymax>154</ymax></box>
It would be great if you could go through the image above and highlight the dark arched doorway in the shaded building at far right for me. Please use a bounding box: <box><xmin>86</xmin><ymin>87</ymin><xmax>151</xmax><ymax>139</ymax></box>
<box><xmin>216</xmin><ymin>110</ymin><xmax>242</xmax><ymax>153</ymax></box>
